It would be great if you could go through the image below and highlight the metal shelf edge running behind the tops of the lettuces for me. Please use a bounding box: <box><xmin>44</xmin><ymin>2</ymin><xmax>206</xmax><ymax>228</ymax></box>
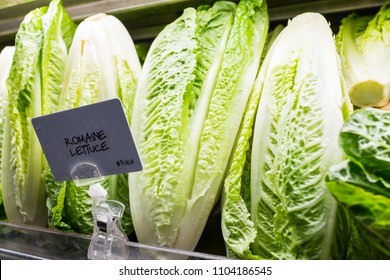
<box><xmin>0</xmin><ymin>0</ymin><xmax>385</xmax><ymax>46</ymax></box>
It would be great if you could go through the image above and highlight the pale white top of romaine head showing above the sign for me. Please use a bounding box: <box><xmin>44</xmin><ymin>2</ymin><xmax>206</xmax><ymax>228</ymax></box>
<box><xmin>59</xmin><ymin>13</ymin><xmax>141</xmax><ymax>122</ymax></box>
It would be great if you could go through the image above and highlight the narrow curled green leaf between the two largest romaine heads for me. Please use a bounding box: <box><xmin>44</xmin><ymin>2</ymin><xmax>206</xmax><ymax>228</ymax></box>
<box><xmin>221</xmin><ymin>21</ymin><xmax>284</xmax><ymax>259</ymax></box>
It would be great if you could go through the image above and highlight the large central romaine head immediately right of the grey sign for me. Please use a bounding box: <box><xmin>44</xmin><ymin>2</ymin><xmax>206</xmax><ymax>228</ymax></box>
<box><xmin>129</xmin><ymin>0</ymin><xmax>269</xmax><ymax>258</ymax></box>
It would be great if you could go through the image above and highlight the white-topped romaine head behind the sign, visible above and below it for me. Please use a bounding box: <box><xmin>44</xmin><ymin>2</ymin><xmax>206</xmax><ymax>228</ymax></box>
<box><xmin>45</xmin><ymin>14</ymin><xmax>141</xmax><ymax>234</ymax></box>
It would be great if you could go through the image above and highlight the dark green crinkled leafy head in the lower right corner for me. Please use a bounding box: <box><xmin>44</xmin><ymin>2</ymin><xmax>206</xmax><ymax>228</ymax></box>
<box><xmin>327</xmin><ymin>108</ymin><xmax>390</xmax><ymax>259</ymax></box>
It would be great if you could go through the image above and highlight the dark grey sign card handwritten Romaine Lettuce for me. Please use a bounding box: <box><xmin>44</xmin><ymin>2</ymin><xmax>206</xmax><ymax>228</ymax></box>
<box><xmin>32</xmin><ymin>98</ymin><xmax>142</xmax><ymax>181</ymax></box>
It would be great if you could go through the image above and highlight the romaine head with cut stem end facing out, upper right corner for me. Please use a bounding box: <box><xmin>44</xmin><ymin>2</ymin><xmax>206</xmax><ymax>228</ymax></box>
<box><xmin>336</xmin><ymin>3</ymin><xmax>390</xmax><ymax>107</ymax></box>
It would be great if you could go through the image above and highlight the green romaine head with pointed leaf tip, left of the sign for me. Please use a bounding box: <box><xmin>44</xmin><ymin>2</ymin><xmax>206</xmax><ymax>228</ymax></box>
<box><xmin>1</xmin><ymin>0</ymin><xmax>76</xmax><ymax>226</ymax></box>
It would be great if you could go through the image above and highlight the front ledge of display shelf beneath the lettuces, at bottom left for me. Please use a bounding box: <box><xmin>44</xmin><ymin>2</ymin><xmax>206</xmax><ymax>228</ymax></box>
<box><xmin>0</xmin><ymin>222</ymin><xmax>225</xmax><ymax>260</ymax></box>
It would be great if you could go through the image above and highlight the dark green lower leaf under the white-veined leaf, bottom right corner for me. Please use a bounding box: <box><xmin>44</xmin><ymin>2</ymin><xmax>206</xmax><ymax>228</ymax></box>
<box><xmin>327</xmin><ymin>181</ymin><xmax>390</xmax><ymax>260</ymax></box>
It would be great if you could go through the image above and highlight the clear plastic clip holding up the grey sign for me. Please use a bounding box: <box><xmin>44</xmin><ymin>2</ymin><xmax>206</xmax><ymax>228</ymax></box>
<box><xmin>71</xmin><ymin>163</ymin><xmax>129</xmax><ymax>260</ymax></box>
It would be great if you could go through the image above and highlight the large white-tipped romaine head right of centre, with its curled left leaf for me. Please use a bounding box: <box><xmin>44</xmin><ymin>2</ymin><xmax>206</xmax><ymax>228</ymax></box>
<box><xmin>222</xmin><ymin>13</ymin><xmax>351</xmax><ymax>259</ymax></box>
